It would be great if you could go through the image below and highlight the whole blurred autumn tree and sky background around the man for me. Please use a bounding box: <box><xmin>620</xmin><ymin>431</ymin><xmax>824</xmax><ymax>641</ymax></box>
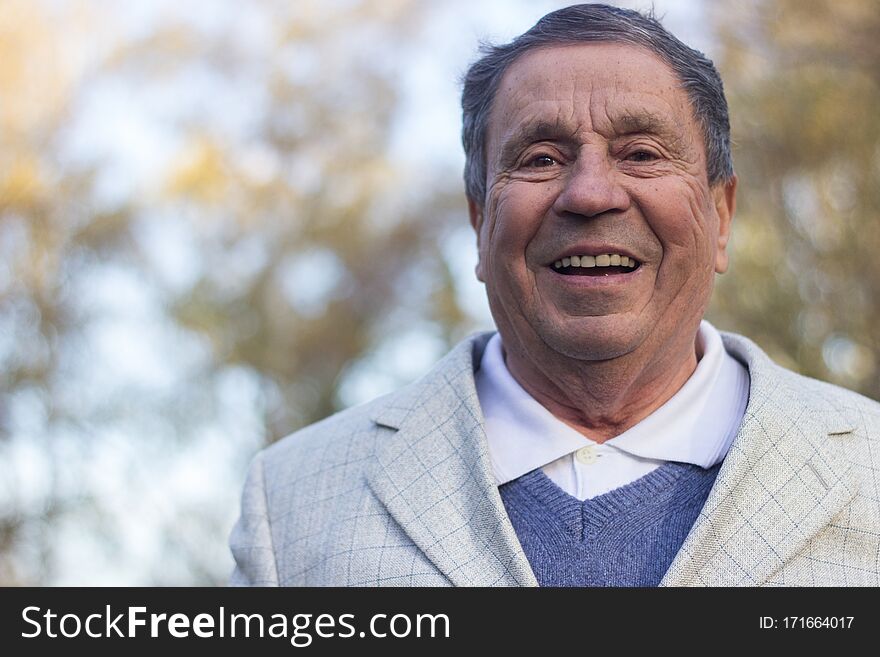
<box><xmin>0</xmin><ymin>0</ymin><xmax>880</xmax><ymax>585</ymax></box>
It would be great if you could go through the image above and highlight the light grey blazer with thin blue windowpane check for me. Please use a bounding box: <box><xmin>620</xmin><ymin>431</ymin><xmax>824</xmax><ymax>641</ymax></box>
<box><xmin>230</xmin><ymin>334</ymin><xmax>880</xmax><ymax>586</ymax></box>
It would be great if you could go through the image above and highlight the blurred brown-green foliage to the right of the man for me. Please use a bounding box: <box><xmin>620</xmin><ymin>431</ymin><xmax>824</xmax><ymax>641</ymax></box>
<box><xmin>711</xmin><ymin>0</ymin><xmax>880</xmax><ymax>399</ymax></box>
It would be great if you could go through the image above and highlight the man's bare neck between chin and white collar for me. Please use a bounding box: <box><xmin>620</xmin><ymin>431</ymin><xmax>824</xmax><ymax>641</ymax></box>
<box><xmin>504</xmin><ymin>326</ymin><xmax>697</xmax><ymax>443</ymax></box>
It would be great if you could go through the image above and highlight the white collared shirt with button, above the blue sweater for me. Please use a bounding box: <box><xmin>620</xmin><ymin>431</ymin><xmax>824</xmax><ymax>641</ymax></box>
<box><xmin>475</xmin><ymin>321</ymin><xmax>749</xmax><ymax>500</ymax></box>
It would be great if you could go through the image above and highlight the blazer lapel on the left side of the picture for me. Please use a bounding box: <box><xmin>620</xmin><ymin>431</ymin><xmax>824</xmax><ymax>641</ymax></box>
<box><xmin>368</xmin><ymin>334</ymin><xmax>537</xmax><ymax>586</ymax></box>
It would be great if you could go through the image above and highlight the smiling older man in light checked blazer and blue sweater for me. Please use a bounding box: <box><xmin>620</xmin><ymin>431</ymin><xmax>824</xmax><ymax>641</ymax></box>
<box><xmin>230</xmin><ymin>5</ymin><xmax>880</xmax><ymax>586</ymax></box>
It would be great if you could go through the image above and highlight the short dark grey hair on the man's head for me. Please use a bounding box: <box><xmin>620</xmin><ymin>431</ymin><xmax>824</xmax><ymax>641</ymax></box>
<box><xmin>461</xmin><ymin>4</ymin><xmax>733</xmax><ymax>204</ymax></box>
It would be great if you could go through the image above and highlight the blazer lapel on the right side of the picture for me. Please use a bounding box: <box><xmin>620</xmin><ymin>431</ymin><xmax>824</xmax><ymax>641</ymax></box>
<box><xmin>661</xmin><ymin>334</ymin><xmax>857</xmax><ymax>586</ymax></box>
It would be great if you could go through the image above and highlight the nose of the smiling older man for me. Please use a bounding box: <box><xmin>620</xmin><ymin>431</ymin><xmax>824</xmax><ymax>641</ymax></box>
<box><xmin>553</xmin><ymin>150</ymin><xmax>630</xmax><ymax>217</ymax></box>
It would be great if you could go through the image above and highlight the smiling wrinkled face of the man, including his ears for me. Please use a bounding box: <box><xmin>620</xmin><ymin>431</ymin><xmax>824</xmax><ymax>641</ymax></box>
<box><xmin>470</xmin><ymin>43</ymin><xmax>735</xmax><ymax>360</ymax></box>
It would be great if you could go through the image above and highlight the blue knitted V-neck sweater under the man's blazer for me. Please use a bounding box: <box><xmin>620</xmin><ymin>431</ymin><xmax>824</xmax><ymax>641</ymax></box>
<box><xmin>499</xmin><ymin>462</ymin><xmax>721</xmax><ymax>586</ymax></box>
